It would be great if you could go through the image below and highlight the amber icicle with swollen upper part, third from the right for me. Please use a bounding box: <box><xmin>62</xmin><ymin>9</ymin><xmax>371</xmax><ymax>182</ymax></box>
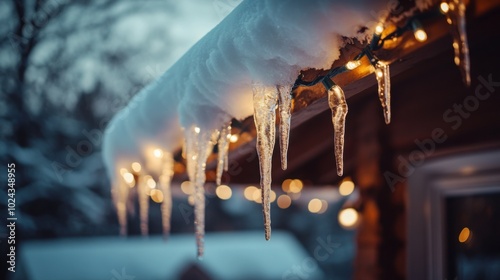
<box><xmin>323</xmin><ymin>77</ymin><xmax>348</xmax><ymax>176</ymax></box>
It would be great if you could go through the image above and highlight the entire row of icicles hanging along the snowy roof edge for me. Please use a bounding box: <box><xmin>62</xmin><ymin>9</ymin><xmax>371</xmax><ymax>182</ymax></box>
<box><xmin>115</xmin><ymin>0</ymin><xmax>470</xmax><ymax>257</ymax></box>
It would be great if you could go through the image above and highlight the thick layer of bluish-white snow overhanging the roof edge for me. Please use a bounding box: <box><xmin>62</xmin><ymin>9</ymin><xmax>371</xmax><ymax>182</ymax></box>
<box><xmin>103</xmin><ymin>0</ymin><xmax>396</xmax><ymax>178</ymax></box>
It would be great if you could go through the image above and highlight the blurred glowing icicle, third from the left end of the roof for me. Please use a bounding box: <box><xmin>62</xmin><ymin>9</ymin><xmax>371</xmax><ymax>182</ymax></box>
<box><xmin>159</xmin><ymin>153</ymin><xmax>174</xmax><ymax>238</ymax></box>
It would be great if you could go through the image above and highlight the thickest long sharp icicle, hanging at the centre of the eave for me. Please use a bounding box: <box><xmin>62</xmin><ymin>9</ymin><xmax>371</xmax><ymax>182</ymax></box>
<box><xmin>253</xmin><ymin>84</ymin><xmax>278</xmax><ymax>240</ymax></box>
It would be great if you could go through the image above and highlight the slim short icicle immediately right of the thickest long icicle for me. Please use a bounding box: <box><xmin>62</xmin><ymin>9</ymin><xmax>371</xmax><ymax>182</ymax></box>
<box><xmin>277</xmin><ymin>86</ymin><xmax>292</xmax><ymax>170</ymax></box>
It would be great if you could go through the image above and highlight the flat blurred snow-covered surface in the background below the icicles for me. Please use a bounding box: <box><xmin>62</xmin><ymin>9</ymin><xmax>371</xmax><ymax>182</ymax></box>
<box><xmin>16</xmin><ymin>232</ymin><xmax>323</xmax><ymax>280</ymax></box>
